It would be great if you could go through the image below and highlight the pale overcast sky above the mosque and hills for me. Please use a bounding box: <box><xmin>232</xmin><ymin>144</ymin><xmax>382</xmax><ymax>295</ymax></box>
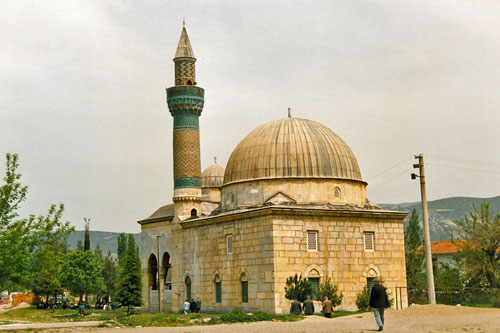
<box><xmin>0</xmin><ymin>0</ymin><xmax>500</xmax><ymax>232</ymax></box>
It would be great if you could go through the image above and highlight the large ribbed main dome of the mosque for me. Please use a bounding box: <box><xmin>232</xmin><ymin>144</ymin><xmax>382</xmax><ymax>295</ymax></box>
<box><xmin>224</xmin><ymin>117</ymin><xmax>362</xmax><ymax>185</ymax></box>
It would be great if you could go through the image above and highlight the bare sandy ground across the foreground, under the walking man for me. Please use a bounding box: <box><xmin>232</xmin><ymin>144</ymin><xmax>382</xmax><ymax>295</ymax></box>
<box><xmin>0</xmin><ymin>305</ymin><xmax>500</xmax><ymax>333</ymax></box>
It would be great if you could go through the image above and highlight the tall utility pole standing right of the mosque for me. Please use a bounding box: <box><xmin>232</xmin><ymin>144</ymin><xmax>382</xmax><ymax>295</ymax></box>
<box><xmin>411</xmin><ymin>154</ymin><xmax>436</xmax><ymax>304</ymax></box>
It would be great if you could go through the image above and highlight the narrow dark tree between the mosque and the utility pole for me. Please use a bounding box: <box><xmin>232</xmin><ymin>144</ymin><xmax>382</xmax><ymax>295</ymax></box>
<box><xmin>405</xmin><ymin>208</ymin><xmax>426</xmax><ymax>287</ymax></box>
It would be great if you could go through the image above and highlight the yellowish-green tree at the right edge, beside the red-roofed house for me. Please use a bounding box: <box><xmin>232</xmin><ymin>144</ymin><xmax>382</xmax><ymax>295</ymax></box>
<box><xmin>455</xmin><ymin>203</ymin><xmax>500</xmax><ymax>288</ymax></box>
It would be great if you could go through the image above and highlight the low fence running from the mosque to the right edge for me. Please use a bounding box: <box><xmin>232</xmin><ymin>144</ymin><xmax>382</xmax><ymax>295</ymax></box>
<box><xmin>396</xmin><ymin>287</ymin><xmax>500</xmax><ymax>309</ymax></box>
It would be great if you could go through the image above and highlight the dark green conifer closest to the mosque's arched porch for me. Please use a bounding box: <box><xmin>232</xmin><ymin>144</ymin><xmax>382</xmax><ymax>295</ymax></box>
<box><xmin>117</xmin><ymin>234</ymin><xmax>142</xmax><ymax>315</ymax></box>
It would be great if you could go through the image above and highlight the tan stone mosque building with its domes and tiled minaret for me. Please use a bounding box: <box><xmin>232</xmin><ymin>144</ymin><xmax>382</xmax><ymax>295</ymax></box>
<box><xmin>138</xmin><ymin>27</ymin><xmax>407</xmax><ymax>313</ymax></box>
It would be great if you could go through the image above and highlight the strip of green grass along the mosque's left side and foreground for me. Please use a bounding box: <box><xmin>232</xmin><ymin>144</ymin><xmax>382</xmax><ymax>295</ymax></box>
<box><xmin>0</xmin><ymin>307</ymin><xmax>304</xmax><ymax>327</ymax></box>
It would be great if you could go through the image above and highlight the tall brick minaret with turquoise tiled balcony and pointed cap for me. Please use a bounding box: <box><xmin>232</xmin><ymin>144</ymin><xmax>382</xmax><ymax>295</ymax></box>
<box><xmin>167</xmin><ymin>22</ymin><xmax>205</xmax><ymax>219</ymax></box>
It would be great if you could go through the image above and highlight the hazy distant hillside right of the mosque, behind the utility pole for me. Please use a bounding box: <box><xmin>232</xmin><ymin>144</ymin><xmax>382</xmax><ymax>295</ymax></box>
<box><xmin>379</xmin><ymin>196</ymin><xmax>500</xmax><ymax>241</ymax></box>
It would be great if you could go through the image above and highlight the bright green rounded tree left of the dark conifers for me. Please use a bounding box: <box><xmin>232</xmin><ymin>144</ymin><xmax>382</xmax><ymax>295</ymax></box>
<box><xmin>60</xmin><ymin>250</ymin><xmax>103</xmax><ymax>300</ymax></box>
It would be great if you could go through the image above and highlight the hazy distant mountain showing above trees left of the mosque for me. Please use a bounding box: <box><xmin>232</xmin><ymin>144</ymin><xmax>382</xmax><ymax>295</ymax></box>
<box><xmin>68</xmin><ymin>230</ymin><xmax>141</xmax><ymax>255</ymax></box>
